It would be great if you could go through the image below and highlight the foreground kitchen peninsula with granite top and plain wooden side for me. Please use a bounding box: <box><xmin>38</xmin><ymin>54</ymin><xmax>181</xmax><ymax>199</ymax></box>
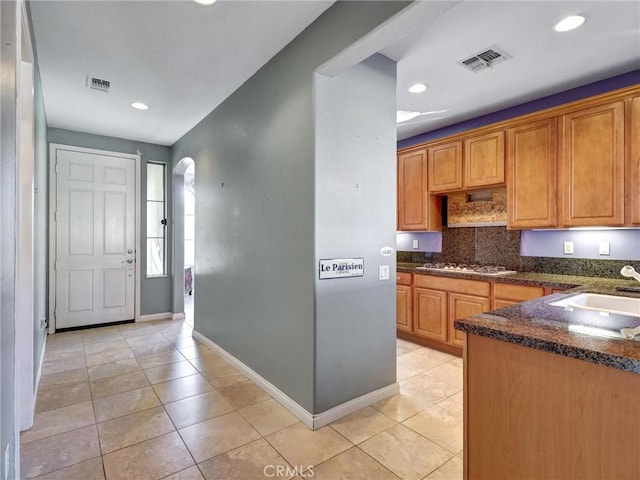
<box><xmin>454</xmin><ymin>286</ymin><xmax>640</xmax><ymax>480</ymax></box>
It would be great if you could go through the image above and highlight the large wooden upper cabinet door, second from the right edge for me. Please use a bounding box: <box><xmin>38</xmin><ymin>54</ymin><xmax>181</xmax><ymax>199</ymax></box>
<box><xmin>560</xmin><ymin>101</ymin><xmax>624</xmax><ymax>227</ymax></box>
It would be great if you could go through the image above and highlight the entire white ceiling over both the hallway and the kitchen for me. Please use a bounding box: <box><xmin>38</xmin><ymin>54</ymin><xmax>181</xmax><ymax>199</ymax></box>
<box><xmin>31</xmin><ymin>0</ymin><xmax>640</xmax><ymax>145</ymax></box>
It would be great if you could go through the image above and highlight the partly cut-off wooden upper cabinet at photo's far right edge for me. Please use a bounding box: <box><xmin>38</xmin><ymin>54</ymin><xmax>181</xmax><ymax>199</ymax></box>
<box><xmin>626</xmin><ymin>96</ymin><xmax>640</xmax><ymax>225</ymax></box>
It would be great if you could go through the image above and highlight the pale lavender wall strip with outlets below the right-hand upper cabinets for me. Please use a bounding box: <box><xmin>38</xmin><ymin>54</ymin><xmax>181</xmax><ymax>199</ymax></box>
<box><xmin>520</xmin><ymin>229</ymin><xmax>640</xmax><ymax>261</ymax></box>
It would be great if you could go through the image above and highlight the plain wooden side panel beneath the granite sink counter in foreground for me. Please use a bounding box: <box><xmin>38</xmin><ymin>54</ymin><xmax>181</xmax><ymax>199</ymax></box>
<box><xmin>464</xmin><ymin>333</ymin><xmax>640</xmax><ymax>480</ymax></box>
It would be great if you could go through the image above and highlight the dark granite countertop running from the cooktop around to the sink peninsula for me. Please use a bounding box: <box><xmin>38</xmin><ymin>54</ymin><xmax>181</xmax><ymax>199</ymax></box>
<box><xmin>398</xmin><ymin>263</ymin><xmax>640</xmax><ymax>374</ymax></box>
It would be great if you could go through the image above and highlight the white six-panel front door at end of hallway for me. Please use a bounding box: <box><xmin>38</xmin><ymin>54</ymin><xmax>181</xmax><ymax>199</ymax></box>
<box><xmin>54</xmin><ymin>148</ymin><xmax>136</xmax><ymax>329</ymax></box>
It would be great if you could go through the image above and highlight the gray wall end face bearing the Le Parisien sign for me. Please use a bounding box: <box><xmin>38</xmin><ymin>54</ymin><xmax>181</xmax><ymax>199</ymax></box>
<box><xmin>315</xmin><ymin>55</ymin><xmax>396</xmax><ymax>411</ymax></box>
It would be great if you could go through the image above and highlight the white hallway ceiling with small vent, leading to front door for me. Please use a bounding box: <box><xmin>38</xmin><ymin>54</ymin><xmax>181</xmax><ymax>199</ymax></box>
<box><xmin>31</xmin><ymin>0</ymin><xmax>333</xmax><ymax>145</ymax></box>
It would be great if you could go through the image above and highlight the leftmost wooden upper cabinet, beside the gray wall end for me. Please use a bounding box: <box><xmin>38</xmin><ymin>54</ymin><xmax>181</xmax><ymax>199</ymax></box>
<box><xmin>398</xmin><ymin>148</ymin><xmax>442</xmax><ymax>230</ymax></box>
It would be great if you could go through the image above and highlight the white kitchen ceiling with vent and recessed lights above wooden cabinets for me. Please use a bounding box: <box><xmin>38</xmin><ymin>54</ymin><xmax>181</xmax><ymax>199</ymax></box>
<box><xmin>382</xmin><ymin>0</ymin><xmax>640</xmax><ymax>139</ymax></box>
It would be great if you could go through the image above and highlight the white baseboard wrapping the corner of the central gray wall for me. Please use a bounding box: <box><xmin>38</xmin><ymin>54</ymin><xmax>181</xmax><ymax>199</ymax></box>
<box><xmin>192</xmin><ymin>330</ymin><xmax>400</xmax><ymax>430</ymax></box>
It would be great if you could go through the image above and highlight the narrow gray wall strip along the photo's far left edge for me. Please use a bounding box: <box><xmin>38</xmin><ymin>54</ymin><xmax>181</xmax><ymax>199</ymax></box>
<box><xmin>0</xmin><ymin>1</ymin><xmax>20</xmax><ymax>478</ymax></box>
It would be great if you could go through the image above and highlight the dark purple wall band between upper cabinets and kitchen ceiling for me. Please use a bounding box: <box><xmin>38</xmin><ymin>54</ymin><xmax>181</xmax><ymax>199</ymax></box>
<box><xmin>398</xmin><ymin>70</ymin><xmax>640</xmax><ymax>148</ymax></box>
